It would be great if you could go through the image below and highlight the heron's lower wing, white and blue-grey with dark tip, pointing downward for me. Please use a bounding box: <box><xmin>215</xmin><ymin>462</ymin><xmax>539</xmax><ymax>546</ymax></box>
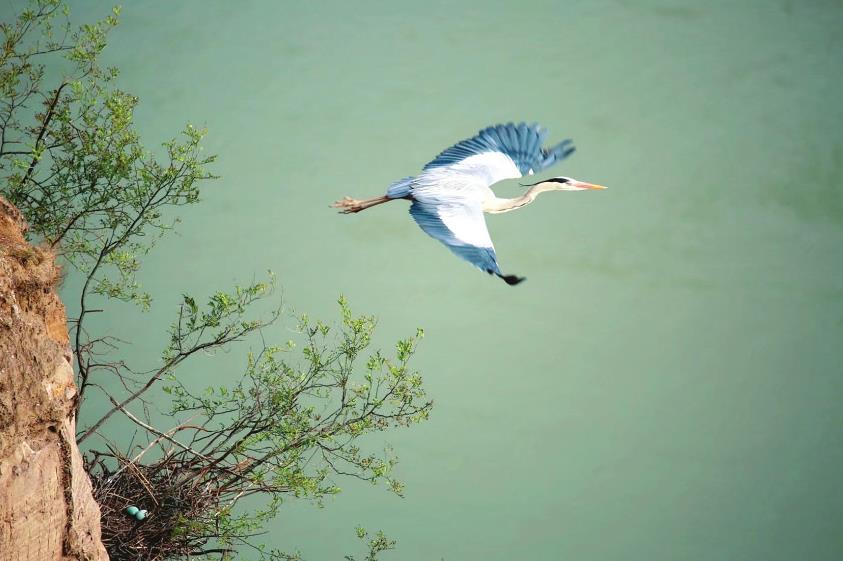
<box><xmin>410</xmin><ymin>201</ymin><xmax>523</xmax><ymax>284</ymax></box>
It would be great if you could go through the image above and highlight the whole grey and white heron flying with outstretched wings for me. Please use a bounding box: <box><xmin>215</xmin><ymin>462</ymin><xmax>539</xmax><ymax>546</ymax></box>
<box><xmin>331</xmin><ymin>123</ymin><xmax>605</xmax><ymax>285</ymax></box>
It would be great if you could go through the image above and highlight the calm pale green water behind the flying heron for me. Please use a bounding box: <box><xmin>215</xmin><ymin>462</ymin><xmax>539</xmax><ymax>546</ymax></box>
<box><xmin>52</xmin><ymin>0</ymin><xmax>843</xmax><ymax>561</ymax></box>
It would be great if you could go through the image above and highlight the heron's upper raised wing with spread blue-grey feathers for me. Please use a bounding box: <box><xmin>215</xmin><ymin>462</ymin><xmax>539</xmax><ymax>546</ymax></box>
<box><xmin>424</xmin><ymin>123</ymin><xmax>574</xmax><ymax>179</ymax></box>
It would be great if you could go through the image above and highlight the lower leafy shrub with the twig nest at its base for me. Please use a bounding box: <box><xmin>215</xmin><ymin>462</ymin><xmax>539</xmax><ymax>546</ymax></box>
<box><xmin>89</xmin><ymin>296</ymin><xmax>431</xmax><ymax>560</ymax></box>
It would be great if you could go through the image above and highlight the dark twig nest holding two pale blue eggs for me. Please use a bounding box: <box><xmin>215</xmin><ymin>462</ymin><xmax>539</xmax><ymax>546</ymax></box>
<box><xmin>88</xmin><ymin>457</ymin><xmax>219</xmax><ymax>561</ymax></box>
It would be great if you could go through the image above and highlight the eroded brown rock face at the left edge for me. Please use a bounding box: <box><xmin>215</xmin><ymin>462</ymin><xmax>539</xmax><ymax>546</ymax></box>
<box><xmin>0</xmin><ymin>197</ymin><xmax>108</xmax><ymax>561</ymax></box>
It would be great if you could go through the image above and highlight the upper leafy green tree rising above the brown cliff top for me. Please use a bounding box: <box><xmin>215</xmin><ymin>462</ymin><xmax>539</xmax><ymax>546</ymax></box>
<box><xmin>0</xmin><ymin>0</ymin><xmax>214</xmax><ymax>405</ymax></box>
